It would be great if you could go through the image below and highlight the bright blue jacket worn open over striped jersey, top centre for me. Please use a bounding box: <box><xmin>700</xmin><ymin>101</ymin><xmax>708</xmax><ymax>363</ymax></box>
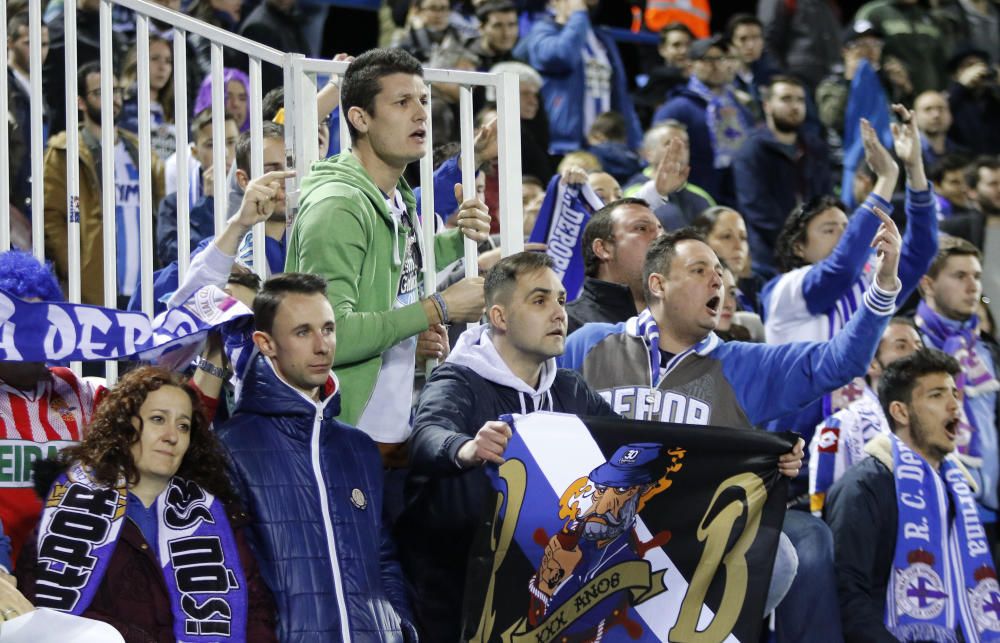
<box><xmin>514</xmin><ymin>11</ymin><xmax>642</xmax><ymax>154</ymax></box>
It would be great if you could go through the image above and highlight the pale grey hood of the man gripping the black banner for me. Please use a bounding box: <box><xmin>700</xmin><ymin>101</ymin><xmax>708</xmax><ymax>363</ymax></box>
<box><xmin>445</xmin><ymin>324</ymin><xmax>558</xmax><ymax>413</ymax></box>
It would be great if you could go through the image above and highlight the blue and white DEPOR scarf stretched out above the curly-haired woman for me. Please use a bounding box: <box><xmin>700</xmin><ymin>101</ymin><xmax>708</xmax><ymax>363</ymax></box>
<box><xmin>0</xmin><ymin>286</ymin><xmax>253</xmax><ymax>369</ymax></box>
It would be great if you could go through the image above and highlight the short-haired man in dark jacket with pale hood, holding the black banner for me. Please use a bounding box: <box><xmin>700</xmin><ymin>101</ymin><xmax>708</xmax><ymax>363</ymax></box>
<box><xmin>396</xmin><ymin>252</ymin><xmax>616</xmax><ymax>641</ymax></box>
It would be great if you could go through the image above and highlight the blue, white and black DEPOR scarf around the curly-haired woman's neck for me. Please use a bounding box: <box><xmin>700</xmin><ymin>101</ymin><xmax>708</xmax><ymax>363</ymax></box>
<box><xmin>35</xmin><ymin>464</ymin><xmax>247</xmax><ymax>641</ymax></box>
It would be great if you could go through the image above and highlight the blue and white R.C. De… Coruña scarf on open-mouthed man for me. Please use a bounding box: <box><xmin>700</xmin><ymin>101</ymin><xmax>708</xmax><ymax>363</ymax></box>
<box><xmin>885</xmin><ymin>435</ymin><xmax>1000</xmax><ymax>643</ymax></box>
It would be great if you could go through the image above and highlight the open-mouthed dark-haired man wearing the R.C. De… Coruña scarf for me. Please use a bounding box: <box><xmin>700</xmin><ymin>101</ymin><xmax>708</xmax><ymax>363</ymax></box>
<box><xmin>825</xmin><ymin>348</ymin><xmax>1000</xmax><ymax>641</ymax></box>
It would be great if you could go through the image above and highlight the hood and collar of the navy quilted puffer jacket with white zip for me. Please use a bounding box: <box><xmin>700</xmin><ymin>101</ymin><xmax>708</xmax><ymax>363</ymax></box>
<box><xmin>236</xmin><ymin>353</ymin><xmax>340</xmax><ymax>419</ymax></box>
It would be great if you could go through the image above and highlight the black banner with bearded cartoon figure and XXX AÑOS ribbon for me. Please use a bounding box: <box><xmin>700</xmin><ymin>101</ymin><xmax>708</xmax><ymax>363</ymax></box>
<box><xmin>463</xmin><ymin>413</ymin><xmax>792</xmax><ymax>643</ymax></box>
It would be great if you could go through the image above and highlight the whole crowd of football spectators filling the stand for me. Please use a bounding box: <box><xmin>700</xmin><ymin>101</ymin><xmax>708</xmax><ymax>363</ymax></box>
<box><xmin>0</xmin><ymin>0</ymin><xmax>1000</xmax><ymax>642</ymax></box>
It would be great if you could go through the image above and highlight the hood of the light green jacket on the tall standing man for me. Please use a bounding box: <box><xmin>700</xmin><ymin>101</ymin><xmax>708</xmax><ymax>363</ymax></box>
<box><xmin>300</xmin><ymin>151</ymin><xmax>422</xmax><ymax>266</ymax></box>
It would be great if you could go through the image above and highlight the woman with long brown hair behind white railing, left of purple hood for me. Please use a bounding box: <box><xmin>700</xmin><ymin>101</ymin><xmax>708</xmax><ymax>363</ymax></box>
<box><xmin>122</xmin><ymin>35</ymin><xmax>177</xmax><ymax>160</ymax></box>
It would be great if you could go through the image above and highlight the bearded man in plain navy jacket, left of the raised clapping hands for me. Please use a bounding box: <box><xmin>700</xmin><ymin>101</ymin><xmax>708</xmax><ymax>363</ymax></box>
<box><xmin>733</xmin><ymin>76</ymin><xmax>832</xmax><ymax>269</ymax></box>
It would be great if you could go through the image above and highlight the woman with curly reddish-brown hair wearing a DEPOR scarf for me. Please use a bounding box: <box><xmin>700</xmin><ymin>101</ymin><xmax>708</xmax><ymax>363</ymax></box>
<box><xmin>16</xmin><ymin>367</ymin><xmax>276</xmax><ymax>642</ymax></box>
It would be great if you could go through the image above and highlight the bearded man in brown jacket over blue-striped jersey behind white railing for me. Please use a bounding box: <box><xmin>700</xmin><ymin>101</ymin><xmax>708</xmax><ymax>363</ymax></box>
<box><xmin>45</xmin><ymin>62</ymin><xmax>163</xmax><ymax>308</ymax></box>
